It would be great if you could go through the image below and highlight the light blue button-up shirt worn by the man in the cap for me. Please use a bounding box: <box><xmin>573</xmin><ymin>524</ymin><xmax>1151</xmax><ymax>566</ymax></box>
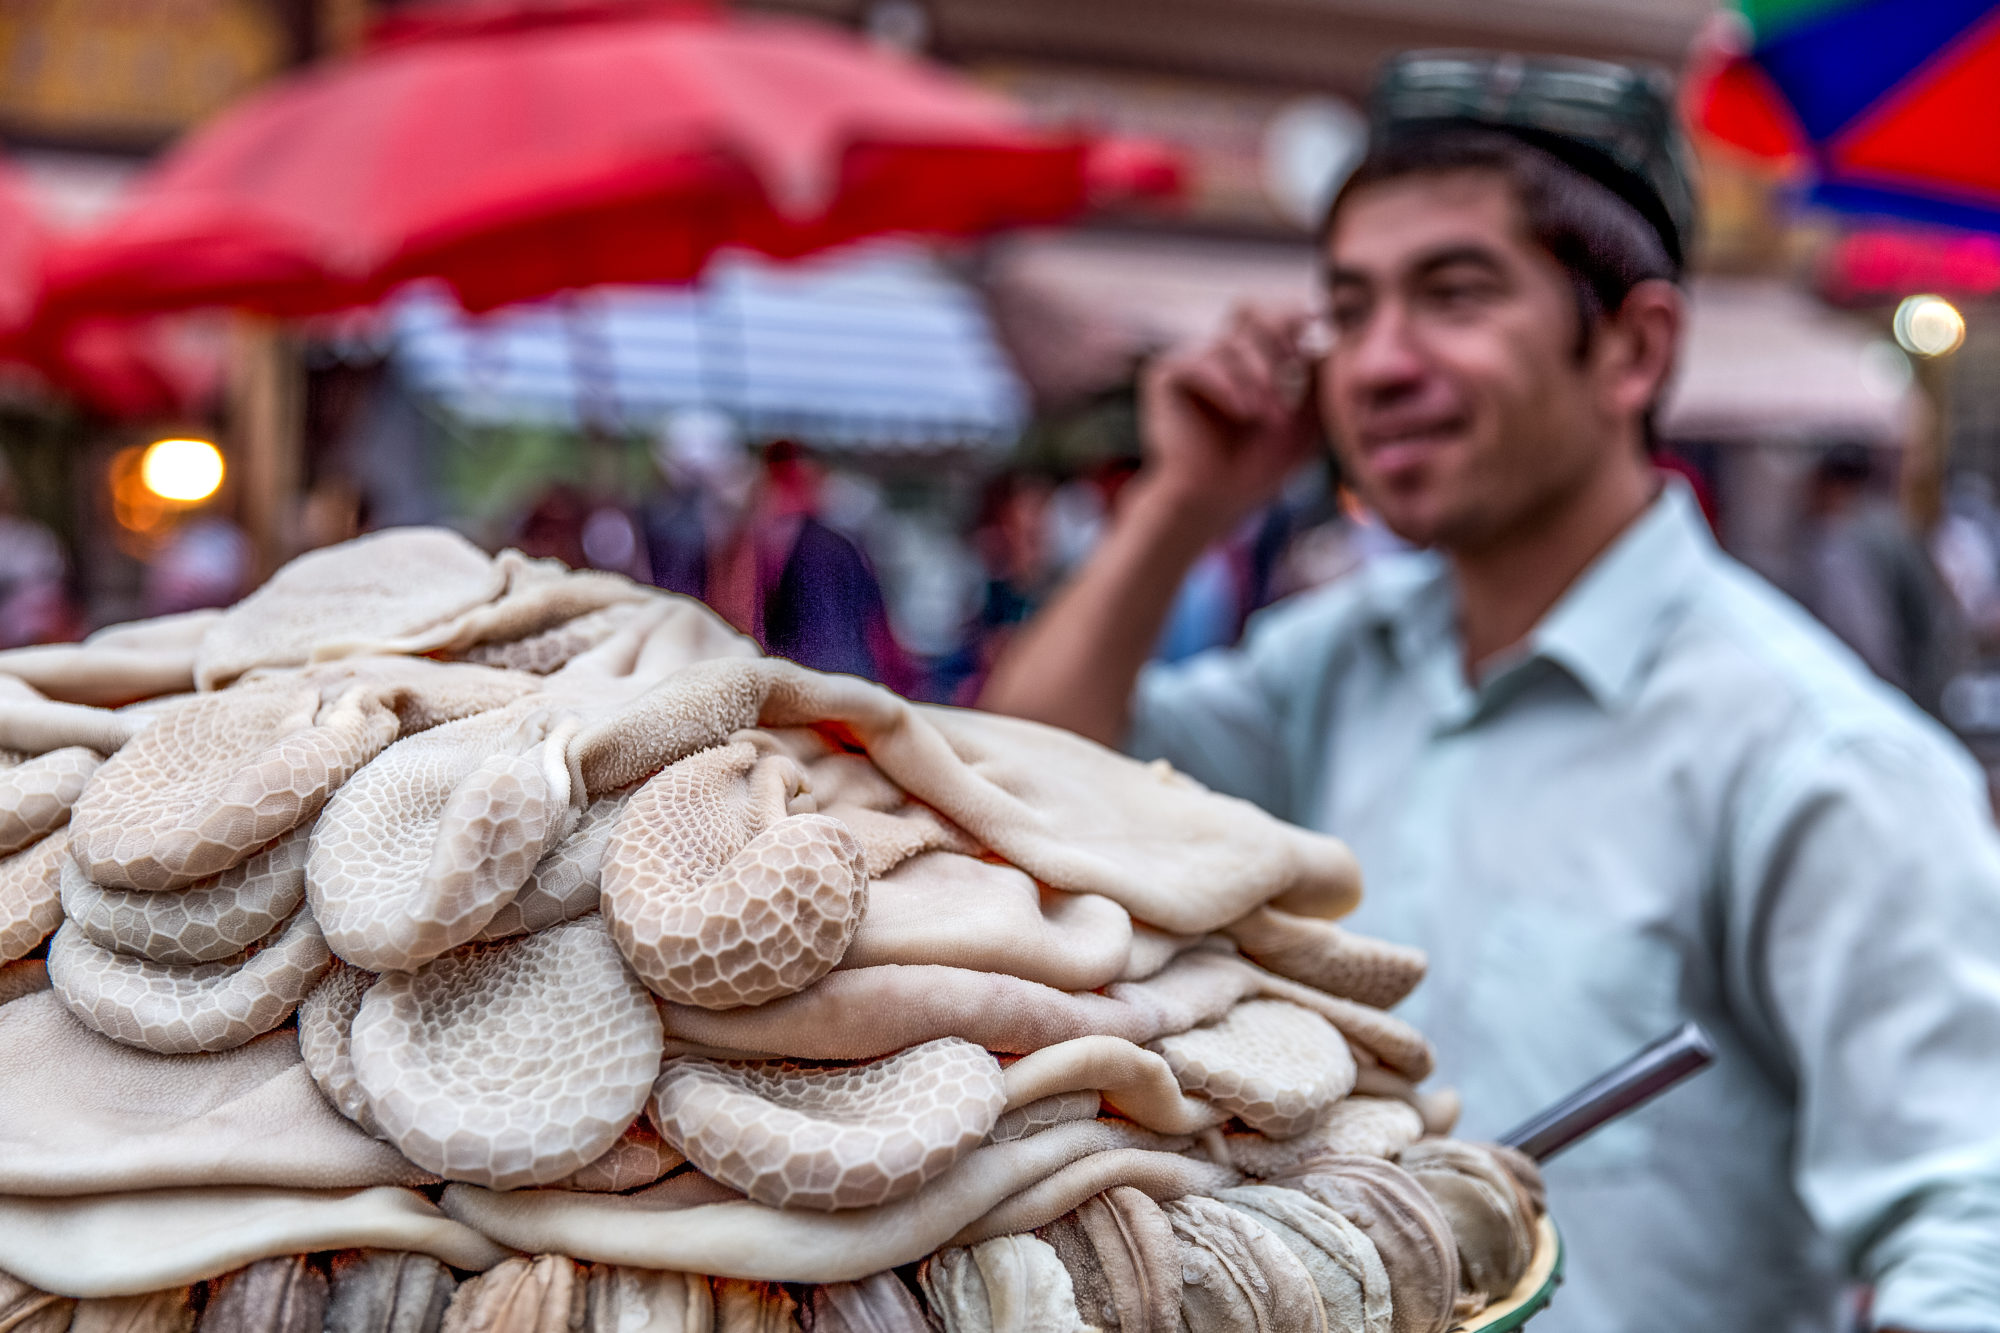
<box><xmin>1128</xmin><ymin>486</ymin><xmax>2000</xmax><ymax>1333</ymax></box>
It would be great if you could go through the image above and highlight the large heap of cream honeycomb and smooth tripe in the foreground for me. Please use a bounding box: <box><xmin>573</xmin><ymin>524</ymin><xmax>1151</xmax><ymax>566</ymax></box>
<box><xmin>0</xmin><ymin>528</ymin><xmax>1540</xmax><ymax>1333</ymax></box>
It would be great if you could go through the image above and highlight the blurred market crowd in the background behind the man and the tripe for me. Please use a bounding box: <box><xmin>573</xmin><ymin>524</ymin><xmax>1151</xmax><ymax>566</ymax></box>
<box><xmin>0</xmin><ymin>414</ymin><xmax>2000</xmax><ymax>732</ymax></box>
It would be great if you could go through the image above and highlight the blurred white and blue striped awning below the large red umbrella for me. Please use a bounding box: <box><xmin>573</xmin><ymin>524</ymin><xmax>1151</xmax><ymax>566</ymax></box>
<box><xmin>390</xmin><ymin>242</ymin><xmax>1028</xmax><ymax>450</ymax></box>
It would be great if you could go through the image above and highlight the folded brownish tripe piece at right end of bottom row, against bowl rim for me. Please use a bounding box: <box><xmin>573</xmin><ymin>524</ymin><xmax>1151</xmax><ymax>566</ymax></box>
<box><xmin>1398</xmin><ymin>1139</ymin><xmax>1536</xmax><ymax>1313</ymax></box>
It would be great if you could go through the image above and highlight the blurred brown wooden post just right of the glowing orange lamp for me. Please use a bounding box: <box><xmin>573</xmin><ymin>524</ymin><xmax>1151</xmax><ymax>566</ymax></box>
<box><xmin>228</xmin><ymin>316</ymin><xmax>306</xmax><ymax>582</ymax></box>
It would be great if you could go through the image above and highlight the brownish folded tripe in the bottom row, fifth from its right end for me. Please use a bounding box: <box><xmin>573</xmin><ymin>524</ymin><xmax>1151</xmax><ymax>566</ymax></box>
<box><xmin>1042</xmin><ymin>1185</ymin><xmax>1180</xmax><ymax>1333</ymax></box>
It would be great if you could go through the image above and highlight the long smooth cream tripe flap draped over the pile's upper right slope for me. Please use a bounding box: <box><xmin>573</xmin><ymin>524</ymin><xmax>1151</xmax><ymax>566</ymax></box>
<box><xmin>572</xmin><ymin>658</ymin><xmax>1360</xmax><ymax>935</ymax></box>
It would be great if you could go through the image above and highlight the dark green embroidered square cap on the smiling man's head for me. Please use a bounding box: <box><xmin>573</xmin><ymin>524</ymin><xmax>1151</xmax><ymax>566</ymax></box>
<box><xmin>1368</xmin><ymin>50</ymin><xmax>1694</xmax><ymax>268</ymax></box>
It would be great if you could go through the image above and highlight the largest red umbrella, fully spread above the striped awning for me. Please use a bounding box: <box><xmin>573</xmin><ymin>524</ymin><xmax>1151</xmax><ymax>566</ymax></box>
<box><xmin>48</xmin><ymin>0</ymin><xmax>1172</xmax><ymax>320</ymax></box>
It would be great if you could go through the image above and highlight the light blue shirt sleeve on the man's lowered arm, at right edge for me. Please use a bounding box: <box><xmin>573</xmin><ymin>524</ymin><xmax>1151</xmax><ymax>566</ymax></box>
<box><xmin>1736</xmin><ymin>723</ymin><xmax>2000</xmax><ymax>1333</ymax></box>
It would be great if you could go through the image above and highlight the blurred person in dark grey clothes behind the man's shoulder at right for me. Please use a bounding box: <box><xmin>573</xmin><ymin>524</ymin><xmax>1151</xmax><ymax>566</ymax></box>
<box><xmin>1798</xmin><ymin>444</ymin><xmax>1964</xmax><ymax>715</ymax></box>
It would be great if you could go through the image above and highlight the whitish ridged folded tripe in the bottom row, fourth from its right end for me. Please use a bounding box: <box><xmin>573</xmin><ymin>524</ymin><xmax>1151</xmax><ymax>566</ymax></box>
<box><xmin>1162</xmin><ymin>1199</ymin><xmax>1326</xmax><ymax>1333</ymax></box>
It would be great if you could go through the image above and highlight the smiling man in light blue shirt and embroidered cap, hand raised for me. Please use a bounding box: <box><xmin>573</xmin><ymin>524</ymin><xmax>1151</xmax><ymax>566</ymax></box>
<box><xmin>984</xmin><ymin>56</ymin><xmax>2000</xmax><ymax>1333</ymax></box>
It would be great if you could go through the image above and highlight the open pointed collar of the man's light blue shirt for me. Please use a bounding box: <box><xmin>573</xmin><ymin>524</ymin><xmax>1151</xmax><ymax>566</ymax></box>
<box><xmin>1368</xmin><ymin>476</ymin><xmax>1714</xmax><ymax>713</ymax></box>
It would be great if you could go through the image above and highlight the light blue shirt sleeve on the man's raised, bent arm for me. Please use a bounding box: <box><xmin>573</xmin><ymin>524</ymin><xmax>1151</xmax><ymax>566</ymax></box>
<box><xmin>1124</xmin><ymin>584</ymin><xmax>1358</xmax><ymax>823</ymax></box>
